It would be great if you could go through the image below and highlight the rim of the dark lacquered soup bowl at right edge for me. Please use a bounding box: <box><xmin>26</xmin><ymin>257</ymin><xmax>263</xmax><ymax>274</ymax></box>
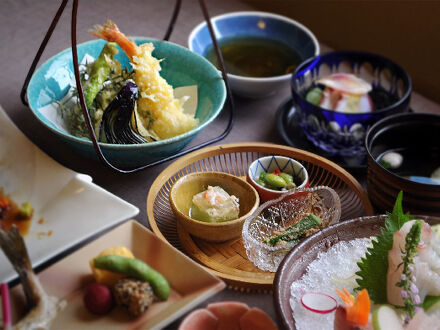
<box><xmin>365</xmin><ymin>113</ymin><xmax>440</xmax><ymax>190</ymax></box>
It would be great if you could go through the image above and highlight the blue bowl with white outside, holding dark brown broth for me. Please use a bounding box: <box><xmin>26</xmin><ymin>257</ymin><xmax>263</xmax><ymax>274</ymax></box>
<box><xmin>188</xmin><ymin>11</ymin><xmax>319</xmax><ymax>98</ymax></box>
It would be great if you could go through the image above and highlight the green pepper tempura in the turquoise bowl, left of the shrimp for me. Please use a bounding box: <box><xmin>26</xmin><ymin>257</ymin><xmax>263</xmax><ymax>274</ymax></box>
<box><xmin>84</xmin><ymin>42</ymin><xmax>118</xmax><ymax>108</ymax></box>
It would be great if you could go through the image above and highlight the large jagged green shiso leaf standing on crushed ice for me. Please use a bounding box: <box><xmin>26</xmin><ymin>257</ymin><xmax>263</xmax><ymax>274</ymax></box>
<box><xmin>356</xmin><ymin>192</ymin><xmax>411</xmax><ymax>304</ymax></box>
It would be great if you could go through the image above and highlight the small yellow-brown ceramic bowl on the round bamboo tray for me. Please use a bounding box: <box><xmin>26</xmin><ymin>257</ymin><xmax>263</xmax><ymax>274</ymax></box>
<box><xmin>170</xmin><ymin>172</ymin><xmax>260</xmax><ymax>242</ymax></box>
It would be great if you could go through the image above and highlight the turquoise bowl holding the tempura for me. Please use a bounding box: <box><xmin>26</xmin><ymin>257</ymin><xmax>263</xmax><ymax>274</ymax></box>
<box><xmin>27</xmin><ymin>37</ymin><xmax>226</xmax><ymax>166</ymax></box>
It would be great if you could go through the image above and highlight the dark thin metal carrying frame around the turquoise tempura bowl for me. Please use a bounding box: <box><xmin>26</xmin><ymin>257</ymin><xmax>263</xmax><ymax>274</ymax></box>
<box><xmin>20</xmin><ymin>0</ymin><xmax>235</xmax><ymax>173</ymax></box>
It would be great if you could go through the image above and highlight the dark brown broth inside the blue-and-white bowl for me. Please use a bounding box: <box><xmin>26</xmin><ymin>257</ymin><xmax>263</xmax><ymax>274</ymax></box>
<box><xmin>206</xmin><ymin>37</ymin><xmax>301</xmax><ymax>78</ymax></box>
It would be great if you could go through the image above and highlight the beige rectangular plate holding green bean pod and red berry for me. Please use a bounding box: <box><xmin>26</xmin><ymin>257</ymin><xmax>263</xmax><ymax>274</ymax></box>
<box><xmin>11</xmin><ymin>220</ymin><xmax>225</xmax><ymax>330</ymax></box>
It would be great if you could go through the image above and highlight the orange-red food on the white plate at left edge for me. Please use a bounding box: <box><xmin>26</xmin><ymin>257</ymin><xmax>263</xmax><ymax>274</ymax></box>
<box><xmin>0</xmin><ymin>189</ymin><xmax>32</xmax><ymax>236</ymax></box>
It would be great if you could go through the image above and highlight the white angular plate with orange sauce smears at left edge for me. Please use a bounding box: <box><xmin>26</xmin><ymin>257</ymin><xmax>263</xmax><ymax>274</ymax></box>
<box><xmin>0</xmin><ymin>107</ymin><xmax>139</xmax><ymax>282</ymax></box>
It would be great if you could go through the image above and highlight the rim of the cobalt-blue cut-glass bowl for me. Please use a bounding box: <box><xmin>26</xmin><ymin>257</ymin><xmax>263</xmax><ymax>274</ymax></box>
<box><xmin>290</xmin><ymin>50</ymin><xmax>412</xmax><ymax>116</ymax></box>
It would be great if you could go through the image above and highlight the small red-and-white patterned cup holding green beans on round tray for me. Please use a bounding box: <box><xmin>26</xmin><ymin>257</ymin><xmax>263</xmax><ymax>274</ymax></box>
<box><xmin>247</xmin><ymin>156</ymin><xmax>309</xmax><ymax>202</ymax></box>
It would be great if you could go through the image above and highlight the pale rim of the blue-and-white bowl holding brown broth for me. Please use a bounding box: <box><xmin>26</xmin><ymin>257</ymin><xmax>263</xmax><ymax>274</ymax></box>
<box><xmin>188</xmin><ymin>11</ymin><xmax>321</xmax><ymax>82</ymax></box>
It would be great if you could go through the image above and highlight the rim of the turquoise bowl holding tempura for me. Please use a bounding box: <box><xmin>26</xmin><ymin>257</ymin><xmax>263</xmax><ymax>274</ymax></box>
<box><xmin>26</xmin><ymin>36</ymin><xmax>226</xmax><ymax>149</ymax></box>
